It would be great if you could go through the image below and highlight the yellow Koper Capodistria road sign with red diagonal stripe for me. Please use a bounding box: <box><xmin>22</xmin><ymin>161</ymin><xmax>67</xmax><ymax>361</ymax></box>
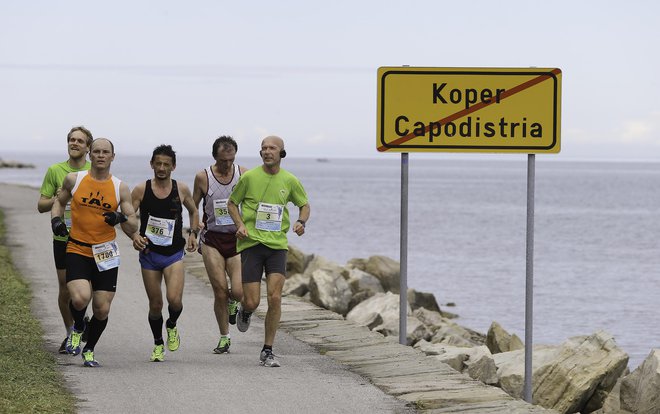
<box><xmin>376</xmin><ymin>67</ymin><xmax>561</xmax><ymax>153</ymax></box>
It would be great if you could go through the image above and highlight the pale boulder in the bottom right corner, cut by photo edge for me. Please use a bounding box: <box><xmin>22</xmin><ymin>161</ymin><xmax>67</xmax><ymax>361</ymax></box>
<box><xmin>620</xmin><ymin>349</ymin><xmax>660</xmax><ymax>414</ymax></box>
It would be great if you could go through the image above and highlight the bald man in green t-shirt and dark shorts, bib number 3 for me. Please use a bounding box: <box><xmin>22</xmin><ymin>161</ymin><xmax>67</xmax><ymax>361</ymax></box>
<box><xmin>227</xmin><ymin>136</ymin><xmax>310</xmax><ymax>367</ymax></box>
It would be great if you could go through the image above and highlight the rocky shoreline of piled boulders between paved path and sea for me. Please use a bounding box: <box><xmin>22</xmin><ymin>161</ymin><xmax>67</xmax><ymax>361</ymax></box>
<box><xmin>284</xmin><ymin>246</ymin><xmax>660</xmax><ymax>414</ymax></box>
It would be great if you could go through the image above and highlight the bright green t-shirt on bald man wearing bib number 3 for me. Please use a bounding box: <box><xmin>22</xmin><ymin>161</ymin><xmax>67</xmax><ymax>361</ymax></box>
<box><xmin>229</xmin><ymin>166</ymin><xmax>307</xmax><ymax>252</ymax></box>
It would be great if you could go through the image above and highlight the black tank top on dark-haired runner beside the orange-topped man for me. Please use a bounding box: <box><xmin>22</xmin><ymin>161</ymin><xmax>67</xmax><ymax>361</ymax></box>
<box><xmin>140</xmin><ymin>180</ymin><xmax>186</xmax><ymax>256</ymax></box>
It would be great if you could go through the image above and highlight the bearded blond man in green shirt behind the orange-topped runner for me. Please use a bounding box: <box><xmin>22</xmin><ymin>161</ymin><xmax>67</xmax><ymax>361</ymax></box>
<box><xmin>37</xmin><ymin>126</ymin><xmax>93</xmax><ymax>354</ymax></box>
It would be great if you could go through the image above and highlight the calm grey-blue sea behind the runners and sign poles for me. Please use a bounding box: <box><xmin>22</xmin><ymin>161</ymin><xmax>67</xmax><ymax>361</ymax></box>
<box><xmin>0</xmin><ymin>152</ymin><xmax>660</xmax><ymax>369</ymax></box>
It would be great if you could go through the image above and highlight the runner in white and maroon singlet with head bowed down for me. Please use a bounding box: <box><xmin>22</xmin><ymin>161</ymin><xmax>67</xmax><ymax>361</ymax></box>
<box><xmin>193</xmin><ymin>136</ymin><xmax>247</xmax><ymax>354</ymax></box>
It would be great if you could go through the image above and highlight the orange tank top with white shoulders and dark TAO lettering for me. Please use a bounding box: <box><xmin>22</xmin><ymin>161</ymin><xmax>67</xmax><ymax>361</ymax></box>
<box><xmin>66</xmin><ymin>171</ymin><xmax>121</xmax><ymax>257</ymax></box>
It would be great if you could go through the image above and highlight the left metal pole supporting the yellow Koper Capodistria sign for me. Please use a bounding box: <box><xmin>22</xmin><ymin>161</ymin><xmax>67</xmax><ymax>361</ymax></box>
<box><xmin>399</xmin><ymin>152</ymin><xmax>408</xmax><ymax>345</ymax></box>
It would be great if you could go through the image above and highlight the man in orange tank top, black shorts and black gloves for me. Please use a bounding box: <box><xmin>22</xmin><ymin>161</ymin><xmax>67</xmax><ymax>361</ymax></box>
<box><xmin>51</xmin><ymin>138</ymin><xmax>138</xmax><ymax>367</ymax></box>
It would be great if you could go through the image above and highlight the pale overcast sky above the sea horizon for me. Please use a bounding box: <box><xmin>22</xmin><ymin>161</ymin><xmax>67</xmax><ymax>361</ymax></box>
<box><xmin>0</xmin><ymin>0</ymin><xmax>660</xmax><ymax>161</ymax></box>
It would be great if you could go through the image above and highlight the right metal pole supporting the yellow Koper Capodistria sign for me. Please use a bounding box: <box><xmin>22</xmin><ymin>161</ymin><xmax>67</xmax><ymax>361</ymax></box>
<box><xmin>523</xmin><ymin>154</ymin><xmax>535</xmax><ymax>404</ymax></box>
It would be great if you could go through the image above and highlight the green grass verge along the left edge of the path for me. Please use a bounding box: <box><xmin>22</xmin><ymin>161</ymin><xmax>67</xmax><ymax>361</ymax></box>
<box><xmin>0</xmin><ymin>211</ymin><xmax>76</xmax><ymax>413</ymax></box>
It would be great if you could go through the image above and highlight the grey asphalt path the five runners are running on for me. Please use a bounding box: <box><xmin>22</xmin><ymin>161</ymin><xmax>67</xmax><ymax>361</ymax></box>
<box><xmin>0</xmin><ymin>184</ymin><xmax>410</xmax><ymax>413</ymax></box>
